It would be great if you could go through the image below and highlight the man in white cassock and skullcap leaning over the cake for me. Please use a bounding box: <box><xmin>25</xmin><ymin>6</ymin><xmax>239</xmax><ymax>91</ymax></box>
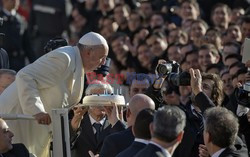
<box><xmin>0</xmin><ymin>32</ymin><xmax>108</xmax><ymax>157</ymax></box>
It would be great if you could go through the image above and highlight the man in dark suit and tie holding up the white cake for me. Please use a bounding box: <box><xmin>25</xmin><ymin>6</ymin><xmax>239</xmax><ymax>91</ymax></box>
<box><xmin>70</xmin><ymin>81</ymin><xmax>125</xmax><ymax>157</ymax></box>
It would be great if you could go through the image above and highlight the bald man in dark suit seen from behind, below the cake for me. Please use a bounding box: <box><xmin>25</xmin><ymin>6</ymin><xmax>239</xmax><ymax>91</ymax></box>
<box><xmin>100</xmin><ymin>94</ymin><xmax>155</xmax><ymax>157</ymax></box>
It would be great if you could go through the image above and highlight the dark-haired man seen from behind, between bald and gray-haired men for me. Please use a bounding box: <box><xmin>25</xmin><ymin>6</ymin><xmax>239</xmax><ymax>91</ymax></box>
<box><xmin>116</xmin><ymin>109</ymin><xmax>155</xmax><ymax>157</ymax></box>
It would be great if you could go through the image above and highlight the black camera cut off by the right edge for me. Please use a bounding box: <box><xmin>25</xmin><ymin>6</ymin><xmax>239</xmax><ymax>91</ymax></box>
<box><xmin>234</xmin><ymin>68</ymin><xmax>250</xmax><ymax>108</ymax></box>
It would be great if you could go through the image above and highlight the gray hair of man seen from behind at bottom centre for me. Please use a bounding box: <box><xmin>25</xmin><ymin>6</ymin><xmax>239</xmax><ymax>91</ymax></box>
<box><xmin>153</xmin><ymin>106</ymin><xmax>186</xmax><ymax>143</ymax></box>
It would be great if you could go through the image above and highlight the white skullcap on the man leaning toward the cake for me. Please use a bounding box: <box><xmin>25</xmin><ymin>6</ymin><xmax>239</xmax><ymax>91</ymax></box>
<box><xmin>79</xmin><ymin>32</ymin><xmax>108</xmax><ymax>47</ymax></box>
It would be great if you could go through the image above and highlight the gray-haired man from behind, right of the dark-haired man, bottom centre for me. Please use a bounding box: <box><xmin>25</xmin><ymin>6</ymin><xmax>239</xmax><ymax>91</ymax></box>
<box><xmin>135</xmin><ymin>106</ymin><xmax>186</xmax><ymax>157</ymax></box>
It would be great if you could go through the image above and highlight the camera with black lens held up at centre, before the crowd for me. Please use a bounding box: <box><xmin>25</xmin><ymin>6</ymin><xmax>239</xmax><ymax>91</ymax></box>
<box><xmin>156</xmin><ymin>61</ymin><xmax>191</xmax><ymax>86</ymax></box>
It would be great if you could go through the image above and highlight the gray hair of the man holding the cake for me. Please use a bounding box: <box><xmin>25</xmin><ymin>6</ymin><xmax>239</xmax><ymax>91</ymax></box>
<box><xmin>85</xmin><ymin>80</ymin><xmax>113</xmax><ymax>95</ymax></box>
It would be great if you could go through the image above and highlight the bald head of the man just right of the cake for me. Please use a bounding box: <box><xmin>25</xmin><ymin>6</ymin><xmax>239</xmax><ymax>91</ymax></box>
<box><xmin>127</xmin><ymin>94</ymin><xmax>155</xmax><ymax>126</ymax></box>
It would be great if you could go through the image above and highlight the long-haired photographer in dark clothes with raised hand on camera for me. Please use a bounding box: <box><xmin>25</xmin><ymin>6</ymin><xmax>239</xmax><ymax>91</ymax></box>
<box><xmin>174</xmin><ymin>68</ymin><xmax>223</xmax><ymax>157</ymax></box>
